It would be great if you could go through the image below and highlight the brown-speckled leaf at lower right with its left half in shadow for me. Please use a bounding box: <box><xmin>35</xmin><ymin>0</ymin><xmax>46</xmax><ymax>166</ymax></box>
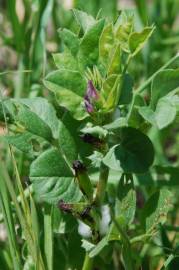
<box><xmin>142</xmin><ymin>189</ymin><xmax>173</xmax><ymax>233</ymax></box>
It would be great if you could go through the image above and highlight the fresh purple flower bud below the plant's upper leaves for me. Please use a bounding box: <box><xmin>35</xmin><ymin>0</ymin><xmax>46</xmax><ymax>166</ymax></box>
<box><xmin>84</xmin><ymin>80</ymin><xmax>99</xmax><ymax>113</ymax></box>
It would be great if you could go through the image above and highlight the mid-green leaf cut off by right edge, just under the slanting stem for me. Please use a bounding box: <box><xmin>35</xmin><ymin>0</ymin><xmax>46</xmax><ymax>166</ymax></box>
<box><xmin>150</xmin><ymin>69</ymin><xmax>179</xmax><ymax>109</ymax></box>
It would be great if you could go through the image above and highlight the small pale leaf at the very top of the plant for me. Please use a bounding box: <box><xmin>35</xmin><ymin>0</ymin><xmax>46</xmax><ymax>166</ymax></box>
<box><xmin>73</xmin><ymin>9</ymin><xmax>96</xmax><ymax>33</ymax></box>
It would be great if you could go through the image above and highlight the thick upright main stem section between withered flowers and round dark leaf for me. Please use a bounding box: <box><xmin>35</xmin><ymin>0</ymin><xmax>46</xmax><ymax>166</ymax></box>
<box><xmin>95</xmin><ymin>163</ymin><xmax>109</xmax><ymax>205</ymax></box>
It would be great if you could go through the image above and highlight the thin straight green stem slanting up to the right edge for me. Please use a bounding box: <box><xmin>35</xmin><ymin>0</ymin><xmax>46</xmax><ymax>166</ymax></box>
<box><xmin>135</xmin><ymin>53</ymin><xmax>179</xmax><ymax>94</ymax></box>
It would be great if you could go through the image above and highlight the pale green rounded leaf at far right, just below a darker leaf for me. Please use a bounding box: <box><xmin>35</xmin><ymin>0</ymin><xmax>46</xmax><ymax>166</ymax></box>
<box><xmin>155</xmin><ymin>98</ymin><xmax>177</xmax><ymax>129</ymax></box>
